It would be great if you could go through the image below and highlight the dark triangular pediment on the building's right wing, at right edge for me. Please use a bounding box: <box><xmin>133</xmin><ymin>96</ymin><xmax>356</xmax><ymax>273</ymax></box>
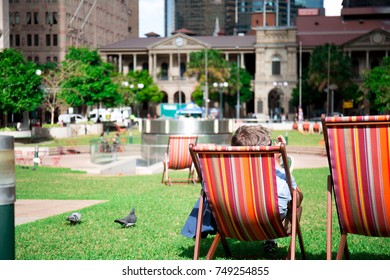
<box><xmin>344</xmin><ymin>29</ymin><xmax>390</xmax><ymax>47</ymax></box>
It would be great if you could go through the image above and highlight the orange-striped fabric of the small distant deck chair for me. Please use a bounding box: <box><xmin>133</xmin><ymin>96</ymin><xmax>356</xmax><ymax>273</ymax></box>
<box><xmin>167</xmin><ymin>135</ymin><xmax>198</xmax><ymax>170</ymax></box>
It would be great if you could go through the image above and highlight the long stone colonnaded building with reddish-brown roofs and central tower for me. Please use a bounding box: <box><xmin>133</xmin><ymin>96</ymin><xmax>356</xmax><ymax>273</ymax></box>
<box><xmin>100</xmin><ymin>3</ymin><xmax>390</xmax><ymax>119</ymax></box>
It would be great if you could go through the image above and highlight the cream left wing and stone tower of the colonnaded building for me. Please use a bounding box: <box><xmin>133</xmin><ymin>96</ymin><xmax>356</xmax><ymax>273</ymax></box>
<box><xmin>99</xmin><ymin>27</ymin><xmax>297</xmax><ymax>117</ymax></box>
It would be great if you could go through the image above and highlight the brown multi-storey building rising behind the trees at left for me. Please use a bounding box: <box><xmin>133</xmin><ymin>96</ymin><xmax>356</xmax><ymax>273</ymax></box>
<box><xmin>6</xmin><ymin>0</ymin><xmax>138</xmax><ymax>63</ymax></box>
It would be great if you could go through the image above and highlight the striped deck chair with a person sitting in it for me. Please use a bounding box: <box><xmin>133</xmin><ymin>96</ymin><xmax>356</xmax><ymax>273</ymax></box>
<box><xmin>190</xmin><ymin>145</ymin><xmax>305</xmax><ymax>259</ymax></box>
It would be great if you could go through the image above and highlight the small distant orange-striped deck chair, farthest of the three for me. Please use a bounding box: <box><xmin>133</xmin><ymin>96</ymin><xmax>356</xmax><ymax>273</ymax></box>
<box><xmin>161</xmin><ymin>135</ymin><xmax>198</xmax><ymax>185</ymax></box>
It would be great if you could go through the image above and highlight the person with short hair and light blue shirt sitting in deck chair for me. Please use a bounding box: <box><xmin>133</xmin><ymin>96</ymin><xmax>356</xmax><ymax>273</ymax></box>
<box><xmin>181</xmin><ymin>125</ymin><xmax>303</xmax><ymax>253</ymax></box>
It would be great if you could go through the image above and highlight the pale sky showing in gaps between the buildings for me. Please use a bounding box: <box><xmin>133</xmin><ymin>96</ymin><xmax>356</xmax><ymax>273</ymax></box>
<box><xmin>139</xmin><ymin>0</ymin><xmax>342</xmax><ymax>37</ymax></box>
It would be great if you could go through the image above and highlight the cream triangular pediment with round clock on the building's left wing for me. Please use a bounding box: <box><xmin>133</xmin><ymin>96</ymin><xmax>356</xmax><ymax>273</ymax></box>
<box><xmin>148</xmin><ymin>33</ymin><xmax>208</xmax><ymax>51</ymax></box>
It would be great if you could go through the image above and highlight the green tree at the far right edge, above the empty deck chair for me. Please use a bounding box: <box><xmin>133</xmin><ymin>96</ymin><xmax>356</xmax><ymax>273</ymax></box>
<box><xmin>364</xmin><ymin>56</ymin><xmax>390</xmax><ymax>114</ymax></box>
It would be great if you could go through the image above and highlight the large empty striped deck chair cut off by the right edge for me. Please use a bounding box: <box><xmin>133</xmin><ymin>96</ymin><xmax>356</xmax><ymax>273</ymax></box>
<box><xmin>322</xmin><ymin>115</ymin><xmax>390</xmax><ymax>259</ymax></box>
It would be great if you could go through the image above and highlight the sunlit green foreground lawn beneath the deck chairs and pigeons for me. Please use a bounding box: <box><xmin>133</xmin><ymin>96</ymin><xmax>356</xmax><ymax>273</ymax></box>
<box><xmin>15</xmin><ymin>164</ymin><xmax>390</xmax><ymax>260</ymax></box>
